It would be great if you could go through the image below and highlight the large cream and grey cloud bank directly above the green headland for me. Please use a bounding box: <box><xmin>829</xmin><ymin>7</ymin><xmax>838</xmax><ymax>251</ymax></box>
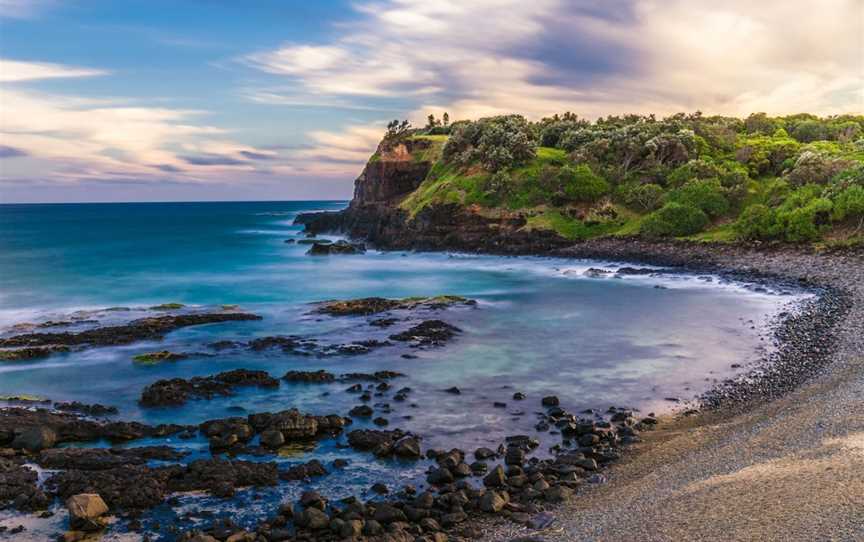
<box><xmin>243</xmin><ymin>0</ymin><xmax>864</xmax><ymax>121</ymax></box>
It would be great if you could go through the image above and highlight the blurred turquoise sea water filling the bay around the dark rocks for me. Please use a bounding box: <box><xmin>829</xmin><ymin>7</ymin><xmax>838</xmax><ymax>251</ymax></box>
<box><xmin>0</xmin><ymin>202</ymin><xmax>799</xmax><ymax>540</ymax></box>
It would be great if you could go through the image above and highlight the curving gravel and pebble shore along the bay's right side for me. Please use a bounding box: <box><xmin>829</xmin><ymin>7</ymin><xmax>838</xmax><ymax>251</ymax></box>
<box><xmin>484</xmin><ymin>240</ymin><xmax>864</xmax><ymax>542</ymax></box>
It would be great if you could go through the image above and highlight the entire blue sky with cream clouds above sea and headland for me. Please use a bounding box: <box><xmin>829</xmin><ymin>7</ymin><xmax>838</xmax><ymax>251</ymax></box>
<box><xmin>0</xmin><ymin>0</ymin><xmax>864</xmax><ymax>203</ymax></box>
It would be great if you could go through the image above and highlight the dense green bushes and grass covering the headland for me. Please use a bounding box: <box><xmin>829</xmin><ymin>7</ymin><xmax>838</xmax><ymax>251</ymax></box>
<box><xmin>388</xmin><ymin>113</ymin><xmax>864</xmax><ymax>243</ymax></box>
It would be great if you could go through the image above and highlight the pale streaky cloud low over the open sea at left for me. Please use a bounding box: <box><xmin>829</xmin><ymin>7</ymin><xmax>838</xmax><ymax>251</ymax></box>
<box><xmin>0</xmin><ymin>61</ymin><xmax>291</xmax><ymax>184</ymax></box>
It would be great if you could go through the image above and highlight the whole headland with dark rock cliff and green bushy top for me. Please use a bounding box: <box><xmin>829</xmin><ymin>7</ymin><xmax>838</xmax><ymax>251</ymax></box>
<box><xmin>297</xmin><ymin>113</ymin><xmax>864</xmax><ymax>253</ymax></box>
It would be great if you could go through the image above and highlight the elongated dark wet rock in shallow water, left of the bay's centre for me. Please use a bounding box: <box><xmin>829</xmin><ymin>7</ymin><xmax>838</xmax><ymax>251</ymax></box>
<box><xmin>139</xmin><ymin>369</ymin><xmax>279</xmax><ymax>407</ymax></box>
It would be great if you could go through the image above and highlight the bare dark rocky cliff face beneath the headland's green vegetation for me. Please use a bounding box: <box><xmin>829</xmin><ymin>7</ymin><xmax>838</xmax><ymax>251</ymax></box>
<box><xmin>295</xmin><ymin>139</ymin><xmax>569</xmax><ymax>254</ymax></box>
